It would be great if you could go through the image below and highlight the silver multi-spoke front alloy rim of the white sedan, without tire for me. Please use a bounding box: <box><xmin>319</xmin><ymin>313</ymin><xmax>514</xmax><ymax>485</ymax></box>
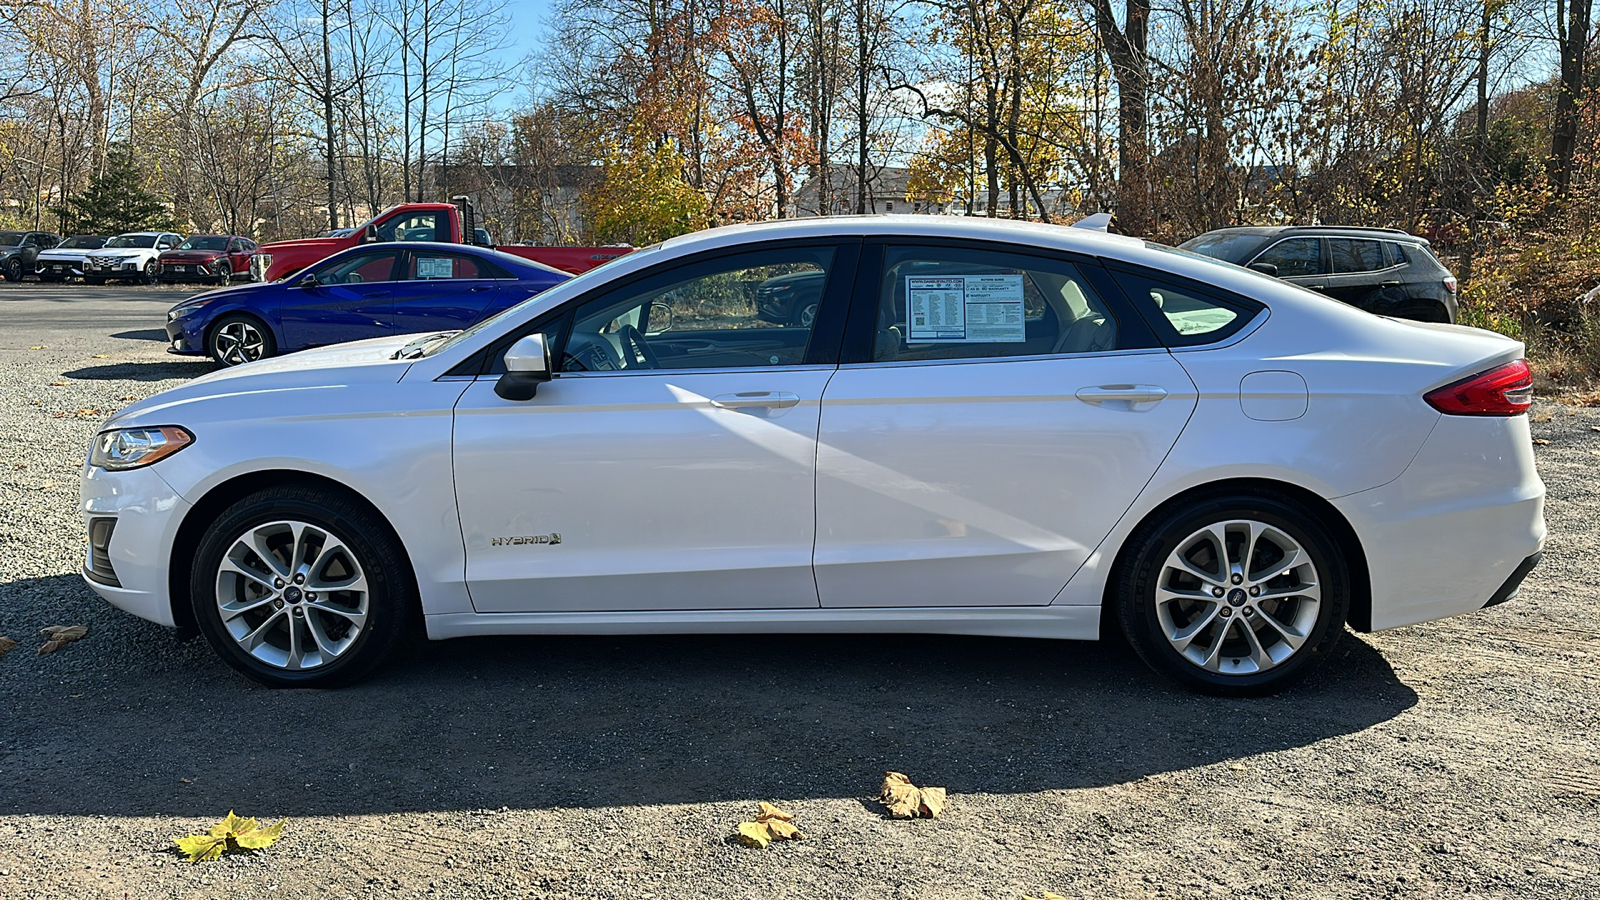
<box><xmin>216</xmin><ymin>520</ymin><xmax>371</xmax><ymax>671</ymax></box>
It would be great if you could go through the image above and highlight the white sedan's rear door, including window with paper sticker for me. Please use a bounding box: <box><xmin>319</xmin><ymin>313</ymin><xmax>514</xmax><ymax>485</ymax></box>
<box><xmin>814</xmin><ymin>242</ymin><xmax>1195</xmax><ymax>607</ymax></box>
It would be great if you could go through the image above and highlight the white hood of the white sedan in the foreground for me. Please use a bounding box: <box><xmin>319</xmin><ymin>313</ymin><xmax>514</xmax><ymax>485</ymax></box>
<box><xmin>102</xmin><ymin>335</ymin><xmax>416</xmax><ymax>428</ymax></box>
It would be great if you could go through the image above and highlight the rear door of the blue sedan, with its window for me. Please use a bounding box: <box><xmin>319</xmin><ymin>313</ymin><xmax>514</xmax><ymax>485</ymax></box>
<box><xmin>394</xmin><ymin>247</ymin><xmax>510</xmax><ymax>335</ymax></box>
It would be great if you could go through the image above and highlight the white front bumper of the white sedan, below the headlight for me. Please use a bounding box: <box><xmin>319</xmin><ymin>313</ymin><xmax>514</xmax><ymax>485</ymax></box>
<box><xmin>78</xmin><ymin>463</ymin><xmax>190</xmax><ymax>626</ymax></box>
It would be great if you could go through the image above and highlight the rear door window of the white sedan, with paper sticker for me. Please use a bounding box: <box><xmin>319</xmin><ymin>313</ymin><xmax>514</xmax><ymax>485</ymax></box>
<box><xmin>872</xmin><ymin>247</ymin><xmax>1117</xmax><ymax>362</ymax></box>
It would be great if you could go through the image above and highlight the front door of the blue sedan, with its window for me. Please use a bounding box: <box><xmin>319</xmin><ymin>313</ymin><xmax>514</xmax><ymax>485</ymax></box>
<box><xmin>280</xmin><ymin>247</ymin><xmax>402</xmax><ymax>349</ymax></box>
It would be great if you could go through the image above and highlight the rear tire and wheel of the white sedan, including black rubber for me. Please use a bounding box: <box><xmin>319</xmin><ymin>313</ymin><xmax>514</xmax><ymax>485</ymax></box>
<box><xmin>1112</xmin><ymin>492</ymin><xmax>1350</xmax><ymax>697</ymax></box>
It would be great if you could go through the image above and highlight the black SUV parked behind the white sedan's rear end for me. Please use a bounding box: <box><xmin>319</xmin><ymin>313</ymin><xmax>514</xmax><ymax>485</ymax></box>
<box><xmin>1179</xmin><ymin>226</ymin><xmax>1456</xmax><ymax>322</ymax></box>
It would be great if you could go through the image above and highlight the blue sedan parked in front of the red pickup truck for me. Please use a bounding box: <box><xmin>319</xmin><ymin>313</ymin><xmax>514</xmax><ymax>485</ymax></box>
<box><xmin>166</xmin><ymin>242</ymin><xmax>571</xmax><ymax>365</ymax></box>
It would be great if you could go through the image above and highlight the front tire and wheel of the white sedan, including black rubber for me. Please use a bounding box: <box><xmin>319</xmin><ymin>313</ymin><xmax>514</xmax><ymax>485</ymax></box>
<box><xmin>189</xmin><ymin>485</ymin><xmax>419</xmax><ymax>687</ymax></box>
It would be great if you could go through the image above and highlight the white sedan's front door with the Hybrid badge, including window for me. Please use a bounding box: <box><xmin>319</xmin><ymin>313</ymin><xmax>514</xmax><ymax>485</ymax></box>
<box><xmin>454</xmin><ymin>245</ymin><xmax>853</xmax><ymax>612</ymax></box>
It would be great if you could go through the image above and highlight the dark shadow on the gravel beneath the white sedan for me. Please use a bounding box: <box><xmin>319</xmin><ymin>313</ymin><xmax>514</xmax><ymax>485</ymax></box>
<box><xmin>0</xmin><ymin>577</ymin><xmax>1416</xmax><ymax>817</ymax></box>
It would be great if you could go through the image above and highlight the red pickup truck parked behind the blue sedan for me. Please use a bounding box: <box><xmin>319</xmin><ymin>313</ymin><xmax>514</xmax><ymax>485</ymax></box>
<box><xmin>250</xmin><ymin>203</ymin><xmax>634</xmax><ymax>282</ymax></box>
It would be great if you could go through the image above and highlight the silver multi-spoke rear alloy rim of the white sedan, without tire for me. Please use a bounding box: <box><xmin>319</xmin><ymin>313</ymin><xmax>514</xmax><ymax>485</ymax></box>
<box><xmin>1155</xmin><ymin>519</ymin><xmax>1322</xmax><ymax>676</ymax></box>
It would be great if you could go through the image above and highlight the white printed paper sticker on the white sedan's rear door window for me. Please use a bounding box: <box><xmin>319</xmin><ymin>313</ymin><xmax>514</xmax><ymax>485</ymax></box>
<box><xmin>906</xmin><ymin>274</ymin><xmax>1027</xmax><ymax>344</ymax></box>
